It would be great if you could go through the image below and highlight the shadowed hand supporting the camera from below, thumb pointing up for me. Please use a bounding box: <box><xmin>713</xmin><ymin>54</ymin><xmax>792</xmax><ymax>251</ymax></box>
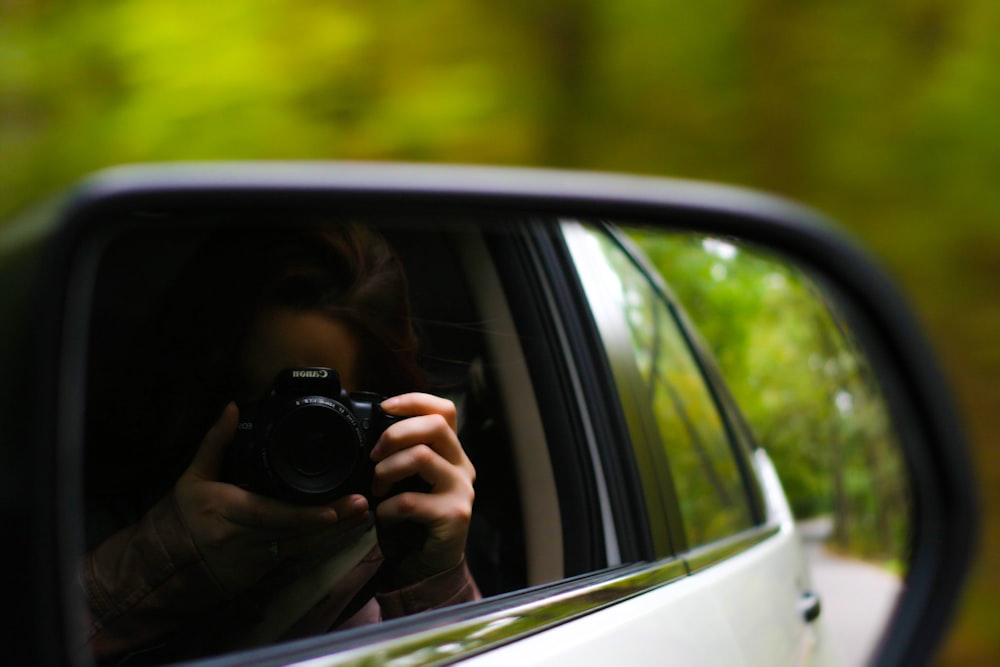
<box><xmin>174</xmin><ymin>403</ymin><xmax>368</xmax><ymax>593</ymax></box>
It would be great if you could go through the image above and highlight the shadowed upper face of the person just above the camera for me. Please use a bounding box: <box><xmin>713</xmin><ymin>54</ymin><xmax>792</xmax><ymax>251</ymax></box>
<box><xmin>240</xmin><ymin>307</ymin><xmax>359</xmax><ymax>399</ymax></box>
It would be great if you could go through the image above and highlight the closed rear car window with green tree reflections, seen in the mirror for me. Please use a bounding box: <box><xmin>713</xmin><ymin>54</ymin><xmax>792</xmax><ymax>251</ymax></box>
<box><xmin>564</xmin><ymin>224</ymin><xmax>753</xmax><ymax>548</ymax></box>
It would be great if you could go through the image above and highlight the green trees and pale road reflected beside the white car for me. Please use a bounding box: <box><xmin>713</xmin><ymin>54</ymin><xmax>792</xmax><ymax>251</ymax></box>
<box><xmin>628</xmin><ymin>228</ymin><xmax>912</xmax><ymax>664</ymax></box>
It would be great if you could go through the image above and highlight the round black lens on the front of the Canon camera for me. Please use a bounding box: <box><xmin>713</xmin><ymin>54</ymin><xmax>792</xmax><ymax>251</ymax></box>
<box><xmin>268</xmin><ymin>405</ymin><xmax>362</xmax><ymax>494</ymax></box>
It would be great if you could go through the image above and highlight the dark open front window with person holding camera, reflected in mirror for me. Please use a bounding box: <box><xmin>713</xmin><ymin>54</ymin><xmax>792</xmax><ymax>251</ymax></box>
<box><xmin>81</xmin><ymin>219</ymin><xmax>561</xmax><ymax>664</ymax></box>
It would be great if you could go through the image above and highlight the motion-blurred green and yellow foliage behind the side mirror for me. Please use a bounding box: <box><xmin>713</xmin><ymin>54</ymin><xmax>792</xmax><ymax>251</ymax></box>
<box><xmin>0</xmin><ymin>0</ymin><xmax>1000</xmax><ymax>665</ymax></box>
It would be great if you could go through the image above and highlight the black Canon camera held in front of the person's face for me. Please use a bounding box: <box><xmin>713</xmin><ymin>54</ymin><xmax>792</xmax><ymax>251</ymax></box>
<box><xmin>222</xmin><ymin>367</ymin><xmax>404</xmax><ymax>505</ymax></box>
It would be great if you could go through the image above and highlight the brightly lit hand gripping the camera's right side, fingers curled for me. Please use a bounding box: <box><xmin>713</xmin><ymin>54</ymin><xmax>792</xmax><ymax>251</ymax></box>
<box><xmin>371</xmin><ymin>393</ymin><xmax>476</xmax><ymax>585</ymax></box>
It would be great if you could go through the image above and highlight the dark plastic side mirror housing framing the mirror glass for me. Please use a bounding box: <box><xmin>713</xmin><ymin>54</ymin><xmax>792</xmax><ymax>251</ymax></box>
<box><xmin>0</xmin><ymin>163</ymin><xmax>977</xmax><ymax>665</ymax></box>
